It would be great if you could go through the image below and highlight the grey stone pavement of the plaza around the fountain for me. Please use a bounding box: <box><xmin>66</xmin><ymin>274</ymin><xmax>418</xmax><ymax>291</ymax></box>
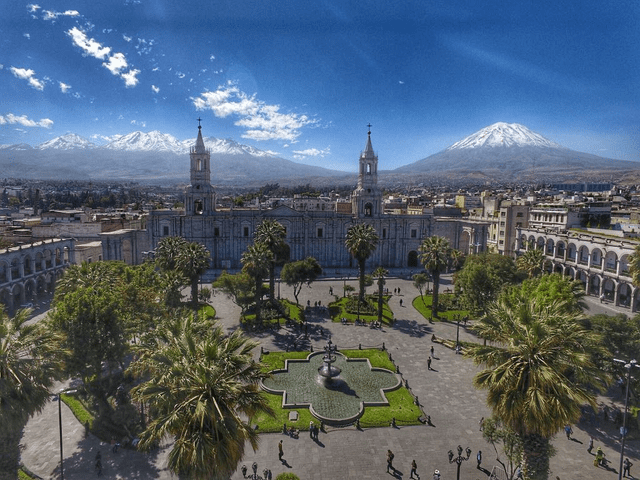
<box><xmin>23</xmin><ymin>272</ymin><xmax>640</xmax><ymax>480</ymax></box>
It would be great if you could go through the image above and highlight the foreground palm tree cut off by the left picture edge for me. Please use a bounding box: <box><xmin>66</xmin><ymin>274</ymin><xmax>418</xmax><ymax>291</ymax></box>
<box><xmin>0</xmin><ymin>310</ymin><xmax>64</xmax><ymax>480</ymax></box>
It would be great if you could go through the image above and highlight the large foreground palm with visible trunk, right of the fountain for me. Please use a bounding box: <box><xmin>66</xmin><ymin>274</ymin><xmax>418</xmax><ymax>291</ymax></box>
<box><xmin>466</xmin><ymin>295</ymin><xmax>606</xmax><ymax>480</ymax></box>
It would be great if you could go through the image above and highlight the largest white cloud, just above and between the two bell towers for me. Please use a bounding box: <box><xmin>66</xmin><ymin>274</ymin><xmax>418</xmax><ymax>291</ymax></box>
<box><xmin>193</xmin><ymin>85</ymin><xmax>316</xmax><ymax>142</ymax></box>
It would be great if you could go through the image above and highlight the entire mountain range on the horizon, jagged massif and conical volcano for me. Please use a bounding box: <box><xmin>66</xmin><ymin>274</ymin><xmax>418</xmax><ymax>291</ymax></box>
<box><xmin>0</xmin><ymin>122</ymin><xmax>640</xmax><ymax>186</ymax></box>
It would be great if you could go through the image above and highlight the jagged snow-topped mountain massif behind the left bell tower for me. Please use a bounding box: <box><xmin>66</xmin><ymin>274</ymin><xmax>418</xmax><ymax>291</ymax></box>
<box><xmin>0</xmin><ymin>131</ymin><xmax>345</xmax><ymax>185</ymax></box>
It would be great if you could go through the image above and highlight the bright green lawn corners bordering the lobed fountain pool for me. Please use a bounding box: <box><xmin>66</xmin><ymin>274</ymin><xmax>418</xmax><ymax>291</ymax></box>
<box><xmin>251</xmin><ymin>348</ymin><xmax>422</xmax><ymax>433</ymax></box>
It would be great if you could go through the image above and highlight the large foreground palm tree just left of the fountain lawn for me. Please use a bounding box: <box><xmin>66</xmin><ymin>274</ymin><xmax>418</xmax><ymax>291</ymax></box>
<box><xmin>131</xmin><ymin>318</ymin><xmax>272</xmax><ymax>480</ymax></box>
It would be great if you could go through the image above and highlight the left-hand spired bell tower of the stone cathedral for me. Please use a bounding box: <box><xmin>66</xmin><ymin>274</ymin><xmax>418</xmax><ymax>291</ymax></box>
<box><xmin>185</xmin><ymin>119</ymin><xmax>216</xmax><ymax>215</ymax></box>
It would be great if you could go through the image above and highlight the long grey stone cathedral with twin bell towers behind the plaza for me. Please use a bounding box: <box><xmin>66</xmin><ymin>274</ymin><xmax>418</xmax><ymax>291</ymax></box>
<box><xmin>147</xmin><ymin>125</ymin><xmax>488</xmax><ymax>279</ymax></box>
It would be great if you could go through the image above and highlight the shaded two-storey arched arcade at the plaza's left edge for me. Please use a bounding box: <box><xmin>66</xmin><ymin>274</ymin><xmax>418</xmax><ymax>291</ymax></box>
<box><xmin>0</xmin><ymin>238</ymin><xmax>74</xmax><ymax>314</ymax></box>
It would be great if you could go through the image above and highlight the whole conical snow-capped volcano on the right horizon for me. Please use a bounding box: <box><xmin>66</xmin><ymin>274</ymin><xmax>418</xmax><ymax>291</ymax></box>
<box><xmin>390</xmin><ymin>122</ymin><xmax>640</xmax><ymax>183</ymax></box>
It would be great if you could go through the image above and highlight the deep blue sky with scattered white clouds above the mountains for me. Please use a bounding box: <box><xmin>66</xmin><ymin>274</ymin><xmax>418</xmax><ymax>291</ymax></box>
<box><xmin>0</xmin><ymin>0</ymin><xmax>640</xmax><ymax>171</ymax></box>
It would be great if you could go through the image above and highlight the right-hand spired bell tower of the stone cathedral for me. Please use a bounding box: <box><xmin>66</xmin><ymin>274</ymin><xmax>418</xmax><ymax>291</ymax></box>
<box><xmin>351</xmin><ymin>124</ymin><xmax>382</xmax><ymax>218</ymax></box>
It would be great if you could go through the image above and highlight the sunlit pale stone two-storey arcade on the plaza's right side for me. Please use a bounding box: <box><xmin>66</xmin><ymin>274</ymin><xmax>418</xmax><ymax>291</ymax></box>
<box><xmin>516</xmin><ymin>228</ymin><xmax>640</xmax><ymax>313</ymax></box>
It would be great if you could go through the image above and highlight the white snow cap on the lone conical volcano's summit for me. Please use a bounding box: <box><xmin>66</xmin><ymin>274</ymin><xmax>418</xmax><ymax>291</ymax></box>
<box><xmin>447</xmin><ymin>122</ymin><xmax>564</xmax><ymax>151</ymax></box>
